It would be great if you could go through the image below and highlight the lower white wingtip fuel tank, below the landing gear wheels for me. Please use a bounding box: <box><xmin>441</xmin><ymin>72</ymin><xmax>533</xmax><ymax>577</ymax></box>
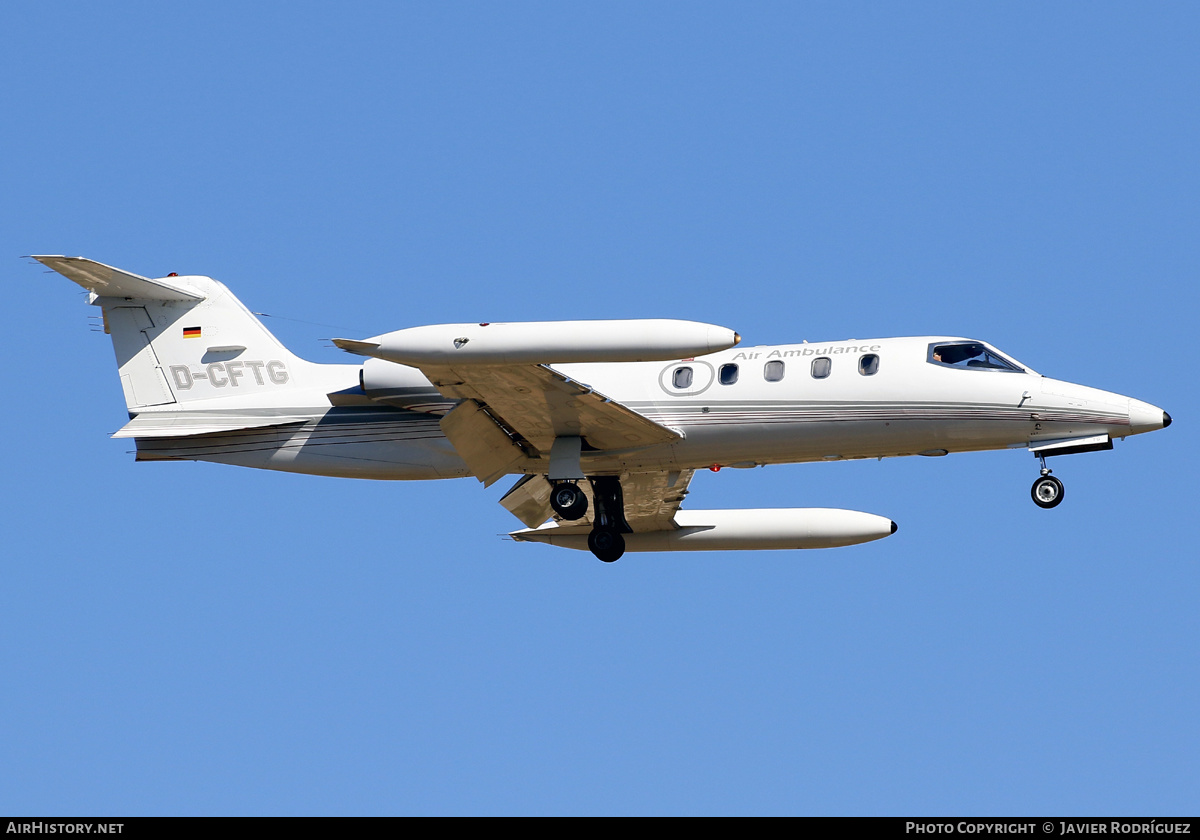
<box><xmin>511</xmin><ymin>508</ymin><xmax>896</xmax><ymax>551</ymax></box>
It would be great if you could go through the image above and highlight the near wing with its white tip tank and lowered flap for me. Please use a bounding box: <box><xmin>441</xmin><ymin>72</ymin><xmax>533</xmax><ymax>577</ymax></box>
<box><xmin>332</xmin><ymin>320</ymin><xmax>705</xmax><ymax>485</ymax></box>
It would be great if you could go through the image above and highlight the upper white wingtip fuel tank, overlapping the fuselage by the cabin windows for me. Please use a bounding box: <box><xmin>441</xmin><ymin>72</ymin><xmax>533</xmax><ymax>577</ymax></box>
<box><xmin>334</xmin><ymin>318</ymin><xmax>742</xmax><ymax>366</ymax></box>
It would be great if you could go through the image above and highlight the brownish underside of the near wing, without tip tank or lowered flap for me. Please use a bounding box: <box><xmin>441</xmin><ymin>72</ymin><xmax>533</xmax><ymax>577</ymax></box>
<box><xmin>420</xmin><ymin>365</ymin><xmax>680</xmax><ymax>456</ymax></box>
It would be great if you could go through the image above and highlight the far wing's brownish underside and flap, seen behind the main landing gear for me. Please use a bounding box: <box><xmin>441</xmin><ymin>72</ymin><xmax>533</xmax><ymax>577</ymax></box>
<box><xmin>500</xmin><ymin>469</ymin><xmax>692</xmax><ymax>534</ymax></box>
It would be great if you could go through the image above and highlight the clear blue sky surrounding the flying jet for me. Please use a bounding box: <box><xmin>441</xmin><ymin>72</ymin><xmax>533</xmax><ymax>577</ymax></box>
<box><xmin>0</xmin><ymin>2</ymin><xmax>1200</xmax><ymax>816</ymax></box>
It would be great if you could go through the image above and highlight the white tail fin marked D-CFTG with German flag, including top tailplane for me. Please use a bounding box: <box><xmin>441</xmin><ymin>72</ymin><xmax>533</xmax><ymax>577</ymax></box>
<box><xmin>34</xmin><ymin>256</ymin><xmax>356</xmax><ymax>414</ymax></box>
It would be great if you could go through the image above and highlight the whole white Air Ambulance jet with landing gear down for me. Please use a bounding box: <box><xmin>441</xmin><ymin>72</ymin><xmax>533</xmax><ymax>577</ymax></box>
<box><xmin>34</xmin><ymin>257</ymin><xmax>1171</xmax><ymax>562</ymax></box>
